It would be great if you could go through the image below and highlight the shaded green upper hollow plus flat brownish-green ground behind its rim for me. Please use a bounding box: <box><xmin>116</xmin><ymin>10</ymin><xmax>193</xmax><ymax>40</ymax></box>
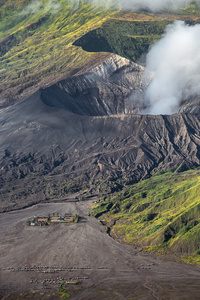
<box><xmin>75</xmin><ymin>5</ymin><xmax>200</xmax><ymax>60</ymax></box>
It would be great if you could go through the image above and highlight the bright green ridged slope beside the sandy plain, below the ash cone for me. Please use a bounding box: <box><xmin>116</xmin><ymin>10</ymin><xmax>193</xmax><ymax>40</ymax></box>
<box><xmin>91</xmin><ymin>170</ymin><xmax>200</xmax><ymax>263</ymax></box>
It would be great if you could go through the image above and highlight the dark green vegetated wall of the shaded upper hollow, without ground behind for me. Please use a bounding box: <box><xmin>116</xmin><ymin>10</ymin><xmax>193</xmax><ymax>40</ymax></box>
<box><xmin>74</xmin><ymin>19</ymin><xmax>171</xmax><ymax>60</ymax></box>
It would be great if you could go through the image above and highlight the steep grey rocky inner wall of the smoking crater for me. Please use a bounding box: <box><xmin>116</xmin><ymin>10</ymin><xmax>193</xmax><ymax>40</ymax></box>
<box><xmin>41</xmin><ymin>55</ymin><xmax>144</xmax><ymax>116</ymax></box>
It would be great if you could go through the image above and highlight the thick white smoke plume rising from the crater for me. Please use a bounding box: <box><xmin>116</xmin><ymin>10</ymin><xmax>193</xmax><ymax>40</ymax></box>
<box><xmin>144</xmin><ymin>21</ymin><xmax>200</xmax><ymax>114</ymax></box>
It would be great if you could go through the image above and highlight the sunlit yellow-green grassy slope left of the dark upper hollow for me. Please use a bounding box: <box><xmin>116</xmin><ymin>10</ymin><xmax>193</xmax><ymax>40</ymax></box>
<box><xmin>0</xmin><ymin>1</ymin><xmax>115</xmax><ymax>102</ymax></box>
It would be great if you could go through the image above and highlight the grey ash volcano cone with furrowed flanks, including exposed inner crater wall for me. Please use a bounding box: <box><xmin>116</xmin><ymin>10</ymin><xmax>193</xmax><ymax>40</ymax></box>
<box><xmin>0</xmin><ymin>56</ymin><xmax>200</xmax><ymax>211</ymax></box>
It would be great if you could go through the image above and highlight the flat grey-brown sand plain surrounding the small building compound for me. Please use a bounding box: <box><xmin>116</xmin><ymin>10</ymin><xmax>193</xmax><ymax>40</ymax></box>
<box><xmin>0</xmin><ymin>201</ymin><xmax>200</xmax><ymax>300</ymax></box>
